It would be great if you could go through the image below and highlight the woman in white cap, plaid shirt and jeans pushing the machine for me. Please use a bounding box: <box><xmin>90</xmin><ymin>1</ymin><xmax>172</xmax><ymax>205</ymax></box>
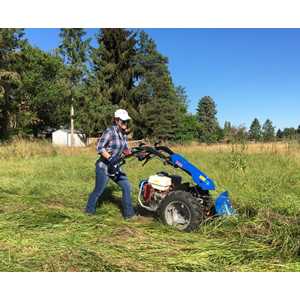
<box><xmin>85</xmin><ymin>109</ymin><xmax>136</xmax><ymax>219</ymax></box>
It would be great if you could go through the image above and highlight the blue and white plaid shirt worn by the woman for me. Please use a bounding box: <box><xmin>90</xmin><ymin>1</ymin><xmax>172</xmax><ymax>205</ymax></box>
<box><xmin>97</xmin><ymin>125</ymin><xmax>128</xmax><ymax>169</ymax></box>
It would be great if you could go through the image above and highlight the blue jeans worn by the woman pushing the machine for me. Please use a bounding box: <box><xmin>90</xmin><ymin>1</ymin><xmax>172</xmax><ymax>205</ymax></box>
<box><xmin>85</xmin><ymin>163</ymin><xmax>135</xmax><ymax>218</ymax></box>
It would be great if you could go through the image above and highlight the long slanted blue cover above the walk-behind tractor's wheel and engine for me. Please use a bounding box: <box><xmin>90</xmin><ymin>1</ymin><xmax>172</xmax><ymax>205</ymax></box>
<box><xmin>170</xmin><ymin>153</ymin><xmax>216</xmax><ymax>191</ymax></box>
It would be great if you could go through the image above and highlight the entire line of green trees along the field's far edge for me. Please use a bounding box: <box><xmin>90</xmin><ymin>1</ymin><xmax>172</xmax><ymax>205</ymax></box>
<box><xmin>0</xmin><ymin>28</ymin><xmax>300</xmax><ymax>143</ymax></box>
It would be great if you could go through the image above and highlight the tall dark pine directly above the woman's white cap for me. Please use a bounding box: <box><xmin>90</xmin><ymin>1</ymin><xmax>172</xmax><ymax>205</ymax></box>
<box><xmin>92</xmin><ymin>28</ymin><xmax>136</xmax><ymax>107</ymax></box>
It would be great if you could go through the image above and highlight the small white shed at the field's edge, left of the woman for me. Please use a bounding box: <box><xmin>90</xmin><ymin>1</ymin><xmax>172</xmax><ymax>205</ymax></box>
<box><xmin>52</xmin><ymin>129</ymin><xmax>86</xmax><ymax>147</ymax></box>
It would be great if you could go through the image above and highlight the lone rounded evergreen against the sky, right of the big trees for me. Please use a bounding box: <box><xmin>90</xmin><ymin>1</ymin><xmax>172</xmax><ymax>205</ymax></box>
<box><xmin>197</xmin><ymin>96</ymin><xmax>219</xmax><ymax>143</ymax></box>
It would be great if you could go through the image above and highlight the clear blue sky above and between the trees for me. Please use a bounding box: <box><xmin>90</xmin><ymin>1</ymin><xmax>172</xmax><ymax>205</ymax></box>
<box><xmin>26</xmin><ymin>29</ymin><xmax>300</xmax><ymax>128</ymax></box>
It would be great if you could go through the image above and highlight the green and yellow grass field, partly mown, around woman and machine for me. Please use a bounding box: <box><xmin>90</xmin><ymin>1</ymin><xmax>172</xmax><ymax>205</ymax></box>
<box><xmin>0</xmin><ymin>141</ymin><xmax>300</xmax><ymax>271</ymax></box>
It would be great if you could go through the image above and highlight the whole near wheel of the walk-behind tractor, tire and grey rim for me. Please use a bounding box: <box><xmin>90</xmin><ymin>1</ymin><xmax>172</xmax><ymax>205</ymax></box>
<box><xmin>158</xmin><ymin>191</ymin><xmax>205</xmax><ymax>232</ymax></box>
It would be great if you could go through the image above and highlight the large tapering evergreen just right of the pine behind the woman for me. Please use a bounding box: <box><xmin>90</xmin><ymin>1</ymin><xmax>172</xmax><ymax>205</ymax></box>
<box><xmin>130</xmin><ymin>31</ymin><xmax>186</xmax><ymax>140</ymax></box>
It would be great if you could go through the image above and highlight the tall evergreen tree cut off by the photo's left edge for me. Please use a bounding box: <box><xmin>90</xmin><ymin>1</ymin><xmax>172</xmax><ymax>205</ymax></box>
<box><xmin>0</xmin><ymin>28</ymin><xmax>24</xmax><ymax>139</ymax></box>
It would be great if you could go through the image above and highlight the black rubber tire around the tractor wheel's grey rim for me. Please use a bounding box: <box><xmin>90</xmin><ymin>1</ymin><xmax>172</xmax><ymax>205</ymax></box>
<box><xmin>158</xmin><ymin>191</ymin><xmax>205</xmax><ymax>232</ymax></box>
